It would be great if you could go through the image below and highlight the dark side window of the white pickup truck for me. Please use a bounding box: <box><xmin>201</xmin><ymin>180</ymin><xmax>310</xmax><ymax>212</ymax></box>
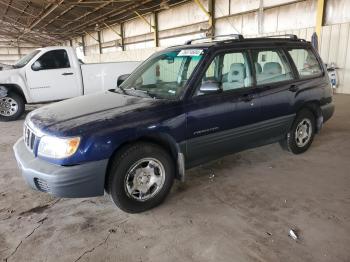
<box><xmin>35</xmin><ymin>49</ymin><xmax>70</xmax><ymax>70</ymax></box>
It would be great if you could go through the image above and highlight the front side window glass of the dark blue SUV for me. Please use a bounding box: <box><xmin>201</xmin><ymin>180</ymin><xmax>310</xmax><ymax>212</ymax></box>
<box><xmin>197</xmin><ymin>52</ymin><xmax>252</xmax><ymax>95</ymax></box>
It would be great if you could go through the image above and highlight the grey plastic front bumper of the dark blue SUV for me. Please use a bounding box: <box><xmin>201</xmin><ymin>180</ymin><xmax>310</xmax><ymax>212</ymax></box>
<box><xmin>13</xmin><ymin>138</ymin><xmax>108</xmax><ymax>198</ymax></box>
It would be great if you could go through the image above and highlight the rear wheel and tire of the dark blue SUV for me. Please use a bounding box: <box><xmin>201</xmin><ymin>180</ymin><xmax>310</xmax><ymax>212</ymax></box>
<box><xmin>280</xmin><ymin>109</ymin><xmax>316</xmax><ymax>154</ymax></box>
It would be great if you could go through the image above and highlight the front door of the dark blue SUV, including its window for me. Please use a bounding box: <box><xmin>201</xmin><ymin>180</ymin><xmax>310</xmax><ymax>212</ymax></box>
<box><xmin>186</xmin><ymin>51</ymin><xmax>260</xmax><ymax>166</ymax></box>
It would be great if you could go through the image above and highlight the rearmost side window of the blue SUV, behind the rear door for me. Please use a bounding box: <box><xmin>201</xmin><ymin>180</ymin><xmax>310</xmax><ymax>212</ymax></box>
<box><xmin>288</xmin><ymin>49</ymin><xmax>322</xmax><ymax>78</ymax></box>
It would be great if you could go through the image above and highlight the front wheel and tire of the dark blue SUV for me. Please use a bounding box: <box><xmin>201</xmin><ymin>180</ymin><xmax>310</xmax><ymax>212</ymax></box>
<box><xmin>107</xmin><ymin>142</ymin><xmax>175</xmax><ymax>213</ymax></box>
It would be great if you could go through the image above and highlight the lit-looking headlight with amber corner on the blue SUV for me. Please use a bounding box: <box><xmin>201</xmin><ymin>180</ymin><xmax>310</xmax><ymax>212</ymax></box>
<box><xmin>38</xmin><ymin>136</ymin><xmax>80</xmax><ymax>158</ymax></box>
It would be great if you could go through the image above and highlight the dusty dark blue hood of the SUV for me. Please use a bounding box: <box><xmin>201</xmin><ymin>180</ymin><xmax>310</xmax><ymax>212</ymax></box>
<box><xmin>28</xmin><ymin>91</ymin><xmax>157</xmax><ymax>135</ymax></box>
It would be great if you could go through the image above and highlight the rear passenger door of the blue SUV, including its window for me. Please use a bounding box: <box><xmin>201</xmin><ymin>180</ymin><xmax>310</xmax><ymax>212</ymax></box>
<box><xmin>251</xmin><ymin>47</ymin><xmax>298</xmax><ymax>144</ymax></box>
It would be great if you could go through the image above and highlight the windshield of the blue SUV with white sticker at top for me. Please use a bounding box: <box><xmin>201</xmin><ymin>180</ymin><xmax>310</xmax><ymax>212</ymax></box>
<box><xmin>120</xmin><ymin>49</ymin><xmax>203</xmax><ymax>99</ymax></box>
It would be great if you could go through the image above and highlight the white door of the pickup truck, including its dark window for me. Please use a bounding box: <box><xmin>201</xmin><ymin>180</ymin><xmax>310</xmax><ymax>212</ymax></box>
<box><xmin>26</xmin><ymin>49</ymin><xmax>80</xmax><ymax>102</ymax></box>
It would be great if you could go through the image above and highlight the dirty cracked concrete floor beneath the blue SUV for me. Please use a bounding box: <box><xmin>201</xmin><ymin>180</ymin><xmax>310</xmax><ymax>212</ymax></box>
<box><xmin>0</xmin><ymin>95</ymin><xmax>350</xmax><ymax>262</ymax></box>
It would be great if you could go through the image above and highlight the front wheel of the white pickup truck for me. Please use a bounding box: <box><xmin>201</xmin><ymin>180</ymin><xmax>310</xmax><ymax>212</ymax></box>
<box><xmin>0</xmin><ymin>92</ymin><xmax>25</xmax><ymax>122</ymax></box>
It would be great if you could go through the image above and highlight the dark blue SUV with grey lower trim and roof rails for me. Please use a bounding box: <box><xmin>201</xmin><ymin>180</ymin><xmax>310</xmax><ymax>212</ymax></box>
<box><xmin>14</xmin><ymin>35</ymin><xmax>334</xmax><ymax>213</ymax></box>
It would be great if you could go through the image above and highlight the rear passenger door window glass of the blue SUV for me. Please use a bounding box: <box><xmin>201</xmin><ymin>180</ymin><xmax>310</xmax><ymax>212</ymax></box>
<box><xmin>252</xmin><ymin>50</ymin><xmax>293</xmax><ymax>85</ymax></box>
